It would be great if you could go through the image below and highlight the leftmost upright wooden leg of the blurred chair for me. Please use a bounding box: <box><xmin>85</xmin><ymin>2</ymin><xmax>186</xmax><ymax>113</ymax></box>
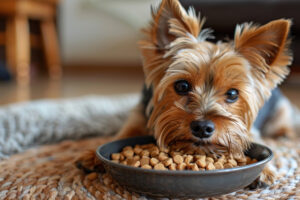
<box><xmin>7</xmin><ymin>16</ymin><xmax>30</xmax><ymax>84</ymax></box>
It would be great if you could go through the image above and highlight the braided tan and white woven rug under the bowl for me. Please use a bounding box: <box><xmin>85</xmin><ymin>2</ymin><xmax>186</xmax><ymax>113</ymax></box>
<box><xmin>0</xmin><ymin>138</ymin><xmax>300</xmax><ymax>200</ymax></box>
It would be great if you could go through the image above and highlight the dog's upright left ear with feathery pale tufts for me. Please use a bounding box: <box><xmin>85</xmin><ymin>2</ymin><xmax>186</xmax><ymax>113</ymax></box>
<box><xmin>146</xmin><ymin>0</ymin><xmax>204</xmax><ymax>50</ymax></box>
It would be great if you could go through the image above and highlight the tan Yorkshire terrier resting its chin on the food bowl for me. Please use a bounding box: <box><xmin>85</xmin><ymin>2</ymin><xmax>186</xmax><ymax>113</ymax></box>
<box><xmin>78</xmin><ymin>0</ymin><xmax>295</xmax><ymax>188</ymax></box>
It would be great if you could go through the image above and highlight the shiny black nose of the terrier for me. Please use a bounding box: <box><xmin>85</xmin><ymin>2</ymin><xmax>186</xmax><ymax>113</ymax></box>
<box><xmin>190</xmin><ymin>120</ymin><xmax>215</xmax><ymax>138</ymax></box>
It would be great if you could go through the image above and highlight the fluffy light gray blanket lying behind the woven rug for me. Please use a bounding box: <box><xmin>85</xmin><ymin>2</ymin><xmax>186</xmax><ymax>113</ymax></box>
<box><xmin>0</xmin><ymin>94</ymin><xmax>139</xmax><ymax>159</ymax></box>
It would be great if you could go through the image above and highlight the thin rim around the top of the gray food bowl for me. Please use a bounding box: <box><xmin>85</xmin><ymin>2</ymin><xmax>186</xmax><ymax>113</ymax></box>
<box><xmin>96</xmin><ymin>136</ymin><xmax>274</xmax><ymax>176</ymax></box>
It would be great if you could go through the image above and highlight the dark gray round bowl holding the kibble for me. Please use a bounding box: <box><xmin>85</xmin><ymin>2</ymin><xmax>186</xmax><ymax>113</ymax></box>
<box><xmin>97</xmin><ymin>136</ymin><xmax>273</xmax><ymax>198</ymax></box>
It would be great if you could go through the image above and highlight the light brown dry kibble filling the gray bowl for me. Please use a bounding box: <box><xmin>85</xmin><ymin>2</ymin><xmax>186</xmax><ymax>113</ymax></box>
<box><xmin>111</xmin><ymin>144</ymin><xmax>257</xmax><ymax>171</ymax></box>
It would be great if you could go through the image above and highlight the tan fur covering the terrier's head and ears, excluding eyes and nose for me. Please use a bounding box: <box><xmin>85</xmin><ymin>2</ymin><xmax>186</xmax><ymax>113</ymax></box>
<box><xmin>140</xmin><ymin>0</ymin><xmax>292</xmax><ymax>184</ymax></box>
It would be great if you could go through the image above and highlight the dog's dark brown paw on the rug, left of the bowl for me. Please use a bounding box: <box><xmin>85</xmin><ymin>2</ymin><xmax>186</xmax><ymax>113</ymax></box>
<box><xmin>75</xmin><ymin>150</ymin><xmax>105</xmax><ymax>174</ymax></box>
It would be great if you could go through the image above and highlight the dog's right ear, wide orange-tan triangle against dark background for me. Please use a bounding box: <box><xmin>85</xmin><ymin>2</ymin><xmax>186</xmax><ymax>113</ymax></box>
<box><xmin>234</xmin><ymin>19</ymin><xmax>292</xmax><ymax>89</ymax></box>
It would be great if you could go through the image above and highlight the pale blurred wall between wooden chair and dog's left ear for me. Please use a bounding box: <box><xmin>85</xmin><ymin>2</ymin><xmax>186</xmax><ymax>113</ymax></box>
<box><xmin>59</xmin><ymin>0</ymin><xmax>154</xmax><ymax>66</ymax></box>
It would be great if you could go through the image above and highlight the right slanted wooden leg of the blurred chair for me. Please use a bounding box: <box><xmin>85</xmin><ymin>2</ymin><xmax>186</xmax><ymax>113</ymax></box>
<box><xmin>41</xmin><ymin>20</ymin><xmax>62</xmax><ymax>79</ymax></box>
